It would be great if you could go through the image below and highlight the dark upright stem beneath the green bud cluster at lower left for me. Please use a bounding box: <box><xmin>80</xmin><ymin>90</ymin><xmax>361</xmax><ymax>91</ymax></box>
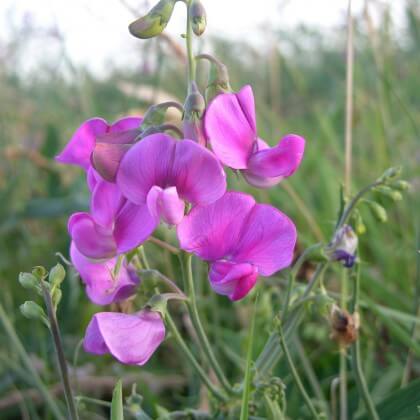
<box><xmin>40</xmin><ymin>282</ymin><xmax>79</xmax><ymax>420</ymax></box>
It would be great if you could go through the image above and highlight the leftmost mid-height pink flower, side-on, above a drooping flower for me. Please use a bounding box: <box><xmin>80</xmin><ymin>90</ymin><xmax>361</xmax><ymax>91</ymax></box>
<box><xmin>68</xmin><ymin>179</ymin><xmax>159</xmax><ymax>259</ymax></box>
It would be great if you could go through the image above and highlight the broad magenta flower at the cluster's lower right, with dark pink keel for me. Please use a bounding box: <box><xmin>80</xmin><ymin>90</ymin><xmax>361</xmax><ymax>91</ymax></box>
<box><xmin>177</xmin><ymin>192</ymin><xmax>296</xmax><ymax>300</ymax></box>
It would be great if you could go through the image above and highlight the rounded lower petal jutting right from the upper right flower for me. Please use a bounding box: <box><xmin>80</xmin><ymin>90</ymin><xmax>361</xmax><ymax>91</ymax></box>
<box><xmin>244</xmin><ymin>134</ymin><xmax>305</xmax><ymax>178</ymax></box>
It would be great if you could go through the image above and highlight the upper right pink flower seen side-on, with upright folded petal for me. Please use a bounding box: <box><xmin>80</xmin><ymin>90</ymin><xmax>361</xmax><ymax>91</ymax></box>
<box><xmin>204</xmin><ymin>86</ymin><xmax>305</xmax><ymax>188</ymax></box>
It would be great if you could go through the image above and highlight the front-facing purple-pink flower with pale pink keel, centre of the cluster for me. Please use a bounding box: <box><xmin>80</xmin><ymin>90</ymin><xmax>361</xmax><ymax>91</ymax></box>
<box><xmin>116</xmin><ymin>133</ymin><xmax>226</xmax><ymax>225</ymax></box>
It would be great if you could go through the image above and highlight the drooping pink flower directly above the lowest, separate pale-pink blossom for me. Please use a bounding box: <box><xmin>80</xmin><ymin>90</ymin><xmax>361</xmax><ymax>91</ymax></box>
<box><xmin>70</xmin><ymin>243</ymin><xmax>140</xmax><ymax>305</ymax></box>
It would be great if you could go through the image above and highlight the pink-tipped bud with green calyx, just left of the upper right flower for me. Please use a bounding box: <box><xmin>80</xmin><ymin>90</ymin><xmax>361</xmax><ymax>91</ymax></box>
<box><xmin>182</xmin><ymin>82</ymin><xmax>206</xmax><ymax>147</ymax></box>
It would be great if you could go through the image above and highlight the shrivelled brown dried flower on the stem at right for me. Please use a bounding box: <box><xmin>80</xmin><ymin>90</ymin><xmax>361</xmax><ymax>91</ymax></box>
<box><xmin>330</xmin><ymin>305</ymin><xmax>360</xmax><ymax>346</ymax></box>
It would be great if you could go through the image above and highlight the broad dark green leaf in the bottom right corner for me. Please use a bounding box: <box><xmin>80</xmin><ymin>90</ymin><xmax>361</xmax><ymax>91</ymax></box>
<box><xmin>357</xmin><ymin>379</ymin><xmax>420</xmax><ymax>420</ymax></box>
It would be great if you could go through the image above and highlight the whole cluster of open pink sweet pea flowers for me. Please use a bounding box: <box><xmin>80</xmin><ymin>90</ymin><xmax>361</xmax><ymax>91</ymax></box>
<box><xmin>57</xmin><ymin>86</ymin><xmax>305</xmax><ymax>365</ymax></box>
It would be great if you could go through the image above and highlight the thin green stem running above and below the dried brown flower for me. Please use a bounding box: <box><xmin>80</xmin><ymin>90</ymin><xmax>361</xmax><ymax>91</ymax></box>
<box><xmin>351</xmin><ymin>264</ymin><xmax>379</xmax><ymax>420</ymax></box>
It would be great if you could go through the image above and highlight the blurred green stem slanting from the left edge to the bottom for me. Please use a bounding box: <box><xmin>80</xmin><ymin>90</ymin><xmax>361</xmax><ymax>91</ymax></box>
<box><xmin>0</xmin><ymin>303</ymin><xmax>65</xmax><ymax>420</ymax></box>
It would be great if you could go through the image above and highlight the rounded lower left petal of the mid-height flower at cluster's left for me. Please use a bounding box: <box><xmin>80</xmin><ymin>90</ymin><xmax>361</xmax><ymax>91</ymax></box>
<box><xmin>68</xmin><ymin>213</ymin><xmax>117</xmax><ymax>259</ymax></box>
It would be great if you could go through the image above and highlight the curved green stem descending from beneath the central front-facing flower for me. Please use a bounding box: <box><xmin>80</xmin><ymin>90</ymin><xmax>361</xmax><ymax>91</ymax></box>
<box><xmin>181</xmin><ymin>253</ymin><xmax>233</xmax><ymax>394</ymax></box>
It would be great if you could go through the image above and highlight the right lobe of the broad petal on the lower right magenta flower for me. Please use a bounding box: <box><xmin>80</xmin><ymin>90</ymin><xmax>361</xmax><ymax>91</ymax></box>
<box><xmin>231</xmin><ymin>204</ymin><xmax>296</xmax><ymax>276</ymax></box>
